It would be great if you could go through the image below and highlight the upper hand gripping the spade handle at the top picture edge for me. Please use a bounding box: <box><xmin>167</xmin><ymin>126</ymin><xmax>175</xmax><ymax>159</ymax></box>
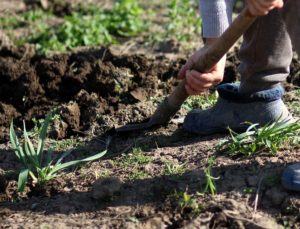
<box><xmin>247</xmin><ymin>0</ymin><xmax>284</xmax><ymax>16</ymax></box>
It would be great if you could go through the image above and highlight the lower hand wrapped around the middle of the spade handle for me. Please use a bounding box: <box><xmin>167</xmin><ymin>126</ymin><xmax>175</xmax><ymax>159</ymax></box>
<box><xmin>178</xmin><ymin>41</ymin><xmax>226</xmax><ymax>95</ymax></box>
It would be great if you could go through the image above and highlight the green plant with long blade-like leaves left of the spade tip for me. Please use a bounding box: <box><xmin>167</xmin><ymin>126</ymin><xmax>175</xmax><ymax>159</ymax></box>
<box><xmin>10</xmin><ymin>114</ymin><xmax>109</xmax><ymax>192</ymax></box>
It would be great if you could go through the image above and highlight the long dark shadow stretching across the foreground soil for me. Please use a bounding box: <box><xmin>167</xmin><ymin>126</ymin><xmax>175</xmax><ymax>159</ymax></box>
<box><xmin>0</xmin><ymin>136</ymin><xmax>300</xmax><ymax>219</ymax></box>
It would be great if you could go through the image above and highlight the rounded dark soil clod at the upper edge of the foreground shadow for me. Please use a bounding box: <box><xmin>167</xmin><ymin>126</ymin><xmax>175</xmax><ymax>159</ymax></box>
<box><xmin>92</xmin><ymin>177</ymin><xmax>122</xmax><ymax>199</ymax></box>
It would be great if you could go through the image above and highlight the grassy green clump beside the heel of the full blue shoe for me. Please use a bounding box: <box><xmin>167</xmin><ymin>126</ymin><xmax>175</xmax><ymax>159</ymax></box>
<box><xmin>217</xmin><ymin>122</ymin><xmax>300</xmax><ymax>156</ymax></box>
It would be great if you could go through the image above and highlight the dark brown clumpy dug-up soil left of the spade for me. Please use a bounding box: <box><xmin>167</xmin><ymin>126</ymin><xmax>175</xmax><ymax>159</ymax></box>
<box><xmin>0</xmin><ymin>46</ymin><xmax>183</xmax><ymax>141</ymax></box>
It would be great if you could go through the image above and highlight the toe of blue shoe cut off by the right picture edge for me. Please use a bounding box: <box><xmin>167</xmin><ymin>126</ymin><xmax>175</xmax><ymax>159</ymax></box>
<box><xmin>281</xmin><ymin>163</ymin><xmax>300</xmax><ymax>191</ymax></box>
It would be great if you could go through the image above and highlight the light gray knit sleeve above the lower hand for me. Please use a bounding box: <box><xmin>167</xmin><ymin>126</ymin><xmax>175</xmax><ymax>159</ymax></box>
<box><xmin>199</xmin><ymin>0</ymin><xmax>236</xmax><ymax>38</ymax></box>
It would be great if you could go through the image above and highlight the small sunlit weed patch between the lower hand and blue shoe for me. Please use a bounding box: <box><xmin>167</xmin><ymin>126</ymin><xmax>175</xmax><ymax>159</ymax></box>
<box><xmin>182</xmin><ymin>91</ymin><xmax>218</xmax><ymax>111</ymax></box>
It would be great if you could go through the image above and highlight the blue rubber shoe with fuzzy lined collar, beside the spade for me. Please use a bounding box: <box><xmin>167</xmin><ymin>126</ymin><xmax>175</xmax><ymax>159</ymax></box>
<box><xmin>183</xmin><ymin>84</ymin><xmax>293</xmax><ymax>135</ymax></box>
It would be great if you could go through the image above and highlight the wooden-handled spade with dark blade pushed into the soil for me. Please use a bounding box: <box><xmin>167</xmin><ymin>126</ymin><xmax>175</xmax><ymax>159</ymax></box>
<box><xmin>116</xmin><ymin>7</ymin><xmax>256</xmax><ymax>132</ymax></box>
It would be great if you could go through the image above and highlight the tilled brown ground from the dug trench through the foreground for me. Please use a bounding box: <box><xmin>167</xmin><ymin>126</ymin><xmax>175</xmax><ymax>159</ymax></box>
<box><xmin>0</xmin><ymin>42</ymin><xmax>300</xmax><ymax>228</ymax></box>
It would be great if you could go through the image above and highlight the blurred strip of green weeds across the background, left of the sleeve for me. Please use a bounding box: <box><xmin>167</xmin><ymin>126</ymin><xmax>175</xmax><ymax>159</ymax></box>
<box><xmin>0</xmin><ymin>0</ymin><xmax>201</xmax><ymax>53</ymax></box>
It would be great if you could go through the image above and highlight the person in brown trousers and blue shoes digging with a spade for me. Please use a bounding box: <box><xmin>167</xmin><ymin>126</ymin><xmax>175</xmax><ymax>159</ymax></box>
<box><xmin>178</xmin><ymin>0</ymin><xmax>300</xmax><ymax>191</ymax></box>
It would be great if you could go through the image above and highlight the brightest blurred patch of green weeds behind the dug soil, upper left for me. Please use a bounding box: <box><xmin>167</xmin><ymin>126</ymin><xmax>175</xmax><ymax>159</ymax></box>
<box><xmin>22</xmin><ymin>0</ymin><xmax>147</xmax><ymax>52</ymax></box>
